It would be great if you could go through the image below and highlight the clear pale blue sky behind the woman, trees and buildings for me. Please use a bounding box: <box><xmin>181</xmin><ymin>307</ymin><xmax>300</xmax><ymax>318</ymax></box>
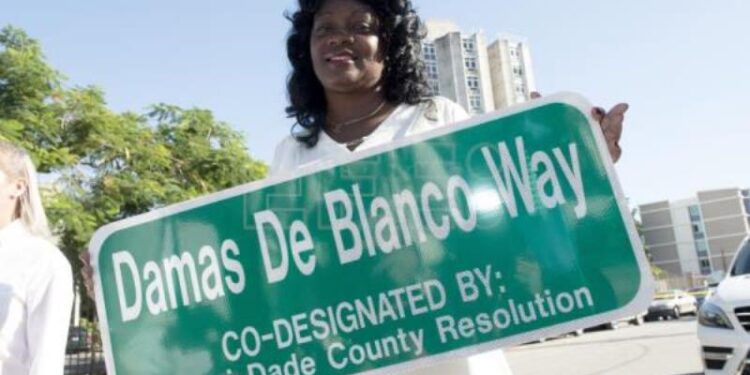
<box><xmin>0</xmin><ymin>0</ymin><xmax>750</xmax><ymax>209</ymax></box>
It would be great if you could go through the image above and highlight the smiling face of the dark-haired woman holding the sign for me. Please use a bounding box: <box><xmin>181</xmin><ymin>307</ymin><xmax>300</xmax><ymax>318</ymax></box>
<box><xmin>310</xmin><ymin>0</ymin><xmax>384</xmax><ymax>93</ymax></box>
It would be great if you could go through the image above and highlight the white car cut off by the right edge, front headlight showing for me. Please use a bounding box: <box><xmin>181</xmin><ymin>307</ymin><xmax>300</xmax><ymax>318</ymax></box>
<box><xmin>698</xmin><ymin>237</ymin><xmax>750</xmax><ymax>375</ymax></box>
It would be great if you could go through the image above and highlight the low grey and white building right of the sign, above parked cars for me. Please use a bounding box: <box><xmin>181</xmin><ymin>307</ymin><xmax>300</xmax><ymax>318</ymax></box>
<box><xmin>639</xmin><ymin>189</ymin><xmax>750</xmax><ymax>276</ymax></box>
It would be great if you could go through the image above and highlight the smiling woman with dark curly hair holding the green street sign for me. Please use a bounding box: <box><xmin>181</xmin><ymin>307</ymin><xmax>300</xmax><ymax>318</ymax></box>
<box><xmin>271</xmin><ymin>0</ymin><xmax>627</xmax><ymax>375</ymax></box>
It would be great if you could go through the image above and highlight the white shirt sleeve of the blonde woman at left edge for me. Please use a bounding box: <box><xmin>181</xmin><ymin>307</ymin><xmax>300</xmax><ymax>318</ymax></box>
<box><xmin>26</xmin><ymin>249</ymin><xmax>73</xmax><ymax>375</ymax></box>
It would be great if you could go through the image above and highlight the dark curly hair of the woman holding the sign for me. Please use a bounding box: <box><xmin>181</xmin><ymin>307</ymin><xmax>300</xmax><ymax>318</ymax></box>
<box><xmin>286</xmin><ymin>0</ymin><xmax>430</xmax><ymax>147</ymax></box>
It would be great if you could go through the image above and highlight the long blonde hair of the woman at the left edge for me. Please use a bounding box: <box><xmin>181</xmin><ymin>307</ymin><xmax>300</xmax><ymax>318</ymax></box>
<box><xmin>0</xmin><ymin>140</ymin><xmax>52</xmax><ymax>240</ymax></box>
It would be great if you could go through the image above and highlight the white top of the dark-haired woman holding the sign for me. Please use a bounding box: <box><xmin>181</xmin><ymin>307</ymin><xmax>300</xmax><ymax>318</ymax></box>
<box><xmin>270</xmin><ymin>97</ymin><xmax>512</xmax><ymax>375</ymax></box>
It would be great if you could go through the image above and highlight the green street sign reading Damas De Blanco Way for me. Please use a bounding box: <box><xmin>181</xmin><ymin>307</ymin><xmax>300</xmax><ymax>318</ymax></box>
<box><xmin>91</xmin><ymin>94</ymin><xmax>652</xmax><ymax>375</ymax></box>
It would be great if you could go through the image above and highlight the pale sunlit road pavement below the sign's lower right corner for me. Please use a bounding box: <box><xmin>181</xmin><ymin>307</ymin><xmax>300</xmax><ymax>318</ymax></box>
<box><xmin>505</xmin><ymin>317</ymin><xmax>703</xmax><ymax>375</ymax></box>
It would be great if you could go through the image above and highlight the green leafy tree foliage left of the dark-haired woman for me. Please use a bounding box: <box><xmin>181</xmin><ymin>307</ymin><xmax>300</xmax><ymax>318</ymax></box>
<box><xmin>0</xmin><ymin>26</ymin><xmax>266</xmax><ymax>300</ymax></box>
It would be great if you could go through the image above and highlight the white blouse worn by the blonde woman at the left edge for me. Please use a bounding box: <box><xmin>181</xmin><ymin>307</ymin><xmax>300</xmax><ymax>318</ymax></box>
<box><xmin>0</xmin><ymin>220</ymin><xmax>73</xmax><ymax>375</ymax></box>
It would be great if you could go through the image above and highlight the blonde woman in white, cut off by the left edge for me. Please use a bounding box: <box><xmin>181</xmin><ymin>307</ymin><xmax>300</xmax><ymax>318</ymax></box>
<box><xmin>0</xmin><ymin>141</ymin><xmax>73</xmax><ymax>375</ymax></box>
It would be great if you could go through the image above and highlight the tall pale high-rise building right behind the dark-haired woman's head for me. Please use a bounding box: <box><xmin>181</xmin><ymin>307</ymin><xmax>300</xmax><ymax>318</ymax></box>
<box><xmin>422</xmin><ymin>21</ymin><xmax>535</xmax><ymax>114</ymax></box>
